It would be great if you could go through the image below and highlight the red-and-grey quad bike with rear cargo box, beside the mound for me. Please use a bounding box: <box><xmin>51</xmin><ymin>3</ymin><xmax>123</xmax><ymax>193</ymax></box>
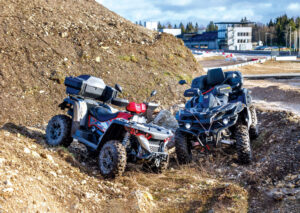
<box><xmin>46</xmin><ymin>75</ymin><xmax>172</xmax><ymax>178</ymax></box>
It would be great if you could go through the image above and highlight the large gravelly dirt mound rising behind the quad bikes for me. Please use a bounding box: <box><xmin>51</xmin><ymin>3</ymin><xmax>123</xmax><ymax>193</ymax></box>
<box><xmin>0</xmin><ymin>0</ymin><xmax>202</xmax><ymax>125</ymax></box>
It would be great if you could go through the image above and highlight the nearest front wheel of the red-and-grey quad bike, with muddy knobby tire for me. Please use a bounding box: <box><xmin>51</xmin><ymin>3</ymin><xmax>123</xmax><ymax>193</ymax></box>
<box><xmin>98</xmin><ymin>140</ymin><xmax>127</xmax><ymax>178</ymax></box>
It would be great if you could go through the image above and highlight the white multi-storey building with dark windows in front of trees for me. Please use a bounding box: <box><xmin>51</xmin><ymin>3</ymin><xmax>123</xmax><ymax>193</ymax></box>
<box><xmin>216</xmin><ymin>22</ymin><xmax>253</xmax><ymax>50</ymax></box>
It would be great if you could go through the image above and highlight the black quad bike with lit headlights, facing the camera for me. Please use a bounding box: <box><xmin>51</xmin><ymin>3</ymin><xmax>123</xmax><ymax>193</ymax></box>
<box><xmin>175</xmin><ymin>68</ymin><xmax>258</xmax><ymax>164</ymax></box>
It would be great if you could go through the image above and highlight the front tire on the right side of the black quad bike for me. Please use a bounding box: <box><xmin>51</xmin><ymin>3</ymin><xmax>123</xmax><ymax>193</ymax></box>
<box><xmin>235</xmin><ymin>124</ymin><xmax>252</xmax><ymax>164</ymax></box>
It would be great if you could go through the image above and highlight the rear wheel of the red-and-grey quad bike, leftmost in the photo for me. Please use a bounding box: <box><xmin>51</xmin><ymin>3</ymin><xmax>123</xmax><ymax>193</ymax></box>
<box><xmin>46</xmin><ymin>115</ymin><xmax>73</xmax><ymax>147</ymax></box>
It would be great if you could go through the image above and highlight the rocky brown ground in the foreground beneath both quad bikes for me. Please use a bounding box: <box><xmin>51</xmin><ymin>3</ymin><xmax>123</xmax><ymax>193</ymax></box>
<box><xmin>0</xmin><ymin>102</ymin><xmax>300</xmax><ymax>212</ymax></box>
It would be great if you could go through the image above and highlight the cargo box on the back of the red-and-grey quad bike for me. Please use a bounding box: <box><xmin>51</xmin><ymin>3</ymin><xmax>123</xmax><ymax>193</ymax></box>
<box><xmin>65</xmin><ymin>75</ymin><xmax>106</xmax><ymax>101</ymax></box>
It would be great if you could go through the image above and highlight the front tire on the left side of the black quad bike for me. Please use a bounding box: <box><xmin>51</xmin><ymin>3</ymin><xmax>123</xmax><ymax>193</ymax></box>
<box><xmin>175</xmin><ymin>130</ymin><xmax>193</xmax><ymax>164</ymax></box>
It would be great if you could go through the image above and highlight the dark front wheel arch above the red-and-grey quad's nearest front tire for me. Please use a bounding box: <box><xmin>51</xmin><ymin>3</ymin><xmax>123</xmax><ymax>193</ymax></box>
<box><xmin>97</xmin><ymin>120</ymin><xmax>126</xmax><ymax>151</ymax></box>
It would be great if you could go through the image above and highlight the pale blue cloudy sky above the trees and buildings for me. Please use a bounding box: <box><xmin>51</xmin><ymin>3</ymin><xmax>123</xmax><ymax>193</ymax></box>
<box><xmin>97</xmin><ymin>0</ymin><xmax>300</xmax><ymax>25</ymax></box>
